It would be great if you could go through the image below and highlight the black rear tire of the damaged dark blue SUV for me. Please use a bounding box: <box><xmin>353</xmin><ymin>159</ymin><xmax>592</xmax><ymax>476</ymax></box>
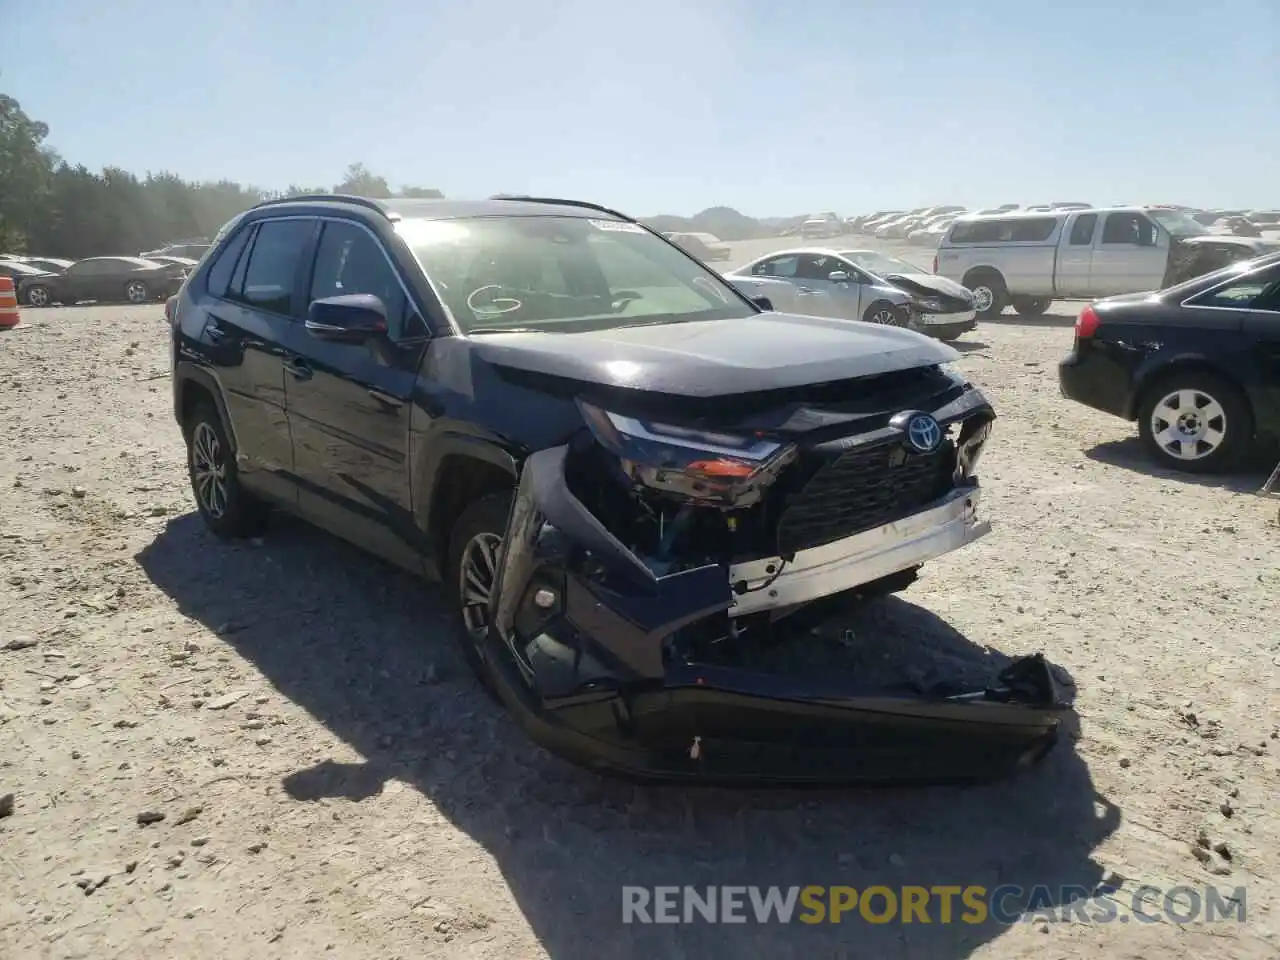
<box><xmin>183</xmin><ymin>403</ymin><xmax>269</xmax><ymax>540</ymax></box>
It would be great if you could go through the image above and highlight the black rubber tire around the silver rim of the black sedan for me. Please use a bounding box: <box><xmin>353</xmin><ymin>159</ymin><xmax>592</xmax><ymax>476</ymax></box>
<box><xmin>1138</xmin><ymin>370</ymin><xmax>1253</xmax><ymax>474</ymax></box>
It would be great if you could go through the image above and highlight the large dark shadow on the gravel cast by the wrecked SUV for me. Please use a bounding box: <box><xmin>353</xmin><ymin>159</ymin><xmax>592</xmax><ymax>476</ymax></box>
<box><xmin>138</xmin><ymin>515</ymin><xmax>1120</xmax><ymax>960</ymax></box>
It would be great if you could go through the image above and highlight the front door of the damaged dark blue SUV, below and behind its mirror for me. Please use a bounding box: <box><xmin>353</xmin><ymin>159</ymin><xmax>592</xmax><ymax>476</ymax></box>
<box><xmin>285</xmin><ymin>219</ymin><xmax>426</xmax><ymax>570</ymax></box>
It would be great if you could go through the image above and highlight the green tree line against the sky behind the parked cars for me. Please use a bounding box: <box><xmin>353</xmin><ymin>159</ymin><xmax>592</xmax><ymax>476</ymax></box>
<box><xmin>0</xmin><ymin>93</ymin><xmax>443</xmax><ymax>260</ymax></box>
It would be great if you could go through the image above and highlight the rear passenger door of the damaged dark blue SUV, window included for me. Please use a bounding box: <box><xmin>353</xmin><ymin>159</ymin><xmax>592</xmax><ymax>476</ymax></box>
<box><xmin>203</xmin><ymin>216</ymin><xmax>319</xmax><ymax>504</ymax></box>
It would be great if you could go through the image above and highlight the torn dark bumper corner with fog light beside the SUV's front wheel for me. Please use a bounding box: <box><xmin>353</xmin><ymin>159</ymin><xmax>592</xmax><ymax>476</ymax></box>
<box><xmin>490</xmin><ymin>447</ymin><xmax>732</xmax><ymax>694</ymax></box>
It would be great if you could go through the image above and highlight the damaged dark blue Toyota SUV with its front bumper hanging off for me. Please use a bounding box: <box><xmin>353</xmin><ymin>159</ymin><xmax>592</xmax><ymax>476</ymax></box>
<box><xmin>166</xmin><ymin>196</ymin><xmax>1061</xmax><ymax>782</ymax></box>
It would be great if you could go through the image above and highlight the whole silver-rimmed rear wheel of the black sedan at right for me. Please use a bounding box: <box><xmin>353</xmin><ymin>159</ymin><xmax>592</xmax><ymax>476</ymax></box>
<box><xmin>1138</xmin><ymin>371</ymin><xmax>1253</xmax><ymax>474</ymax></box>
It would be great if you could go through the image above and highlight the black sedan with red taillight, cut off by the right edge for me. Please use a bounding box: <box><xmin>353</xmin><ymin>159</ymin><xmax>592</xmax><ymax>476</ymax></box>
<box><xmin>1059</xmin><ymin>253</ymin><xmax>1280</xmax><ymax>474</ymax></box>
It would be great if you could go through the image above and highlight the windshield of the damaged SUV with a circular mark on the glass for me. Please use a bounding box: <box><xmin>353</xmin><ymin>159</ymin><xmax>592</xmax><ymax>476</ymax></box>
<box><xmin>396</xmin><ymin>216</ymin><xmax>756</xmax><ymax>333</ymax></box>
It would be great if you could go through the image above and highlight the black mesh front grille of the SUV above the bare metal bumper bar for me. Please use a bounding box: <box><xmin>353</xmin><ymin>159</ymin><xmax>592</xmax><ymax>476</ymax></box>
<box><xmin>778</xmin><ymin>440</ymin><xmax>955</xmax><ymax>556</ymax></box>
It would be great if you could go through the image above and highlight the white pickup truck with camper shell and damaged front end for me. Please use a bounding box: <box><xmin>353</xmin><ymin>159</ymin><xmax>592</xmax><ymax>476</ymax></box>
<box><xmin>933</xmin><ymin>206</ymin><xmax>1274</xmax><ymax>319</ymax></box>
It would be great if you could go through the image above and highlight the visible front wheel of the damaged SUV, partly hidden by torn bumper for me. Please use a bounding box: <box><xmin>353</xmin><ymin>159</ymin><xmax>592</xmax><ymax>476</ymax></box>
<box><xmin>445</xmin><ymin>493</ymin><xmax>511</xmax><ymax>699</ymax></box>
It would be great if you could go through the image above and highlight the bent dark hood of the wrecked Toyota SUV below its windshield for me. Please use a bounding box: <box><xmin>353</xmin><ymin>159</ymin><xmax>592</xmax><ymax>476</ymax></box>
<box><xmin>471</xmin><ymin>311</ymin><xmax>960</xmax><ymax>397</ymax></box>
